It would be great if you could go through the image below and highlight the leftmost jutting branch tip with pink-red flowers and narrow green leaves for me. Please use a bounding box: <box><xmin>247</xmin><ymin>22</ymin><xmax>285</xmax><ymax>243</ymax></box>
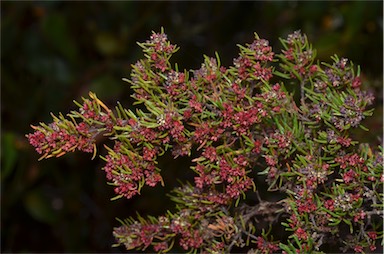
<box><xmin>26</xmin><ymin>93</ymin><xmax>115</xmax><ymax>158</ymax></box>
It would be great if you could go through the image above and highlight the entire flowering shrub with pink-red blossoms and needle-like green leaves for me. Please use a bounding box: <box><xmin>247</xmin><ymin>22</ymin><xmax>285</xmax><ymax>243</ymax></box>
<box><xmin>27</xmin><ymin>28</ymin><xmax>384</xmax><ymax>253</ymax></box>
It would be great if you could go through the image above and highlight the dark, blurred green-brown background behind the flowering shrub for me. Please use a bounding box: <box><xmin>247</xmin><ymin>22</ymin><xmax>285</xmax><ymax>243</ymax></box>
<box><xmin>1</xmin><ymin>1</ymin><xmax>383</xmax><ymax>253</ymax></box>
